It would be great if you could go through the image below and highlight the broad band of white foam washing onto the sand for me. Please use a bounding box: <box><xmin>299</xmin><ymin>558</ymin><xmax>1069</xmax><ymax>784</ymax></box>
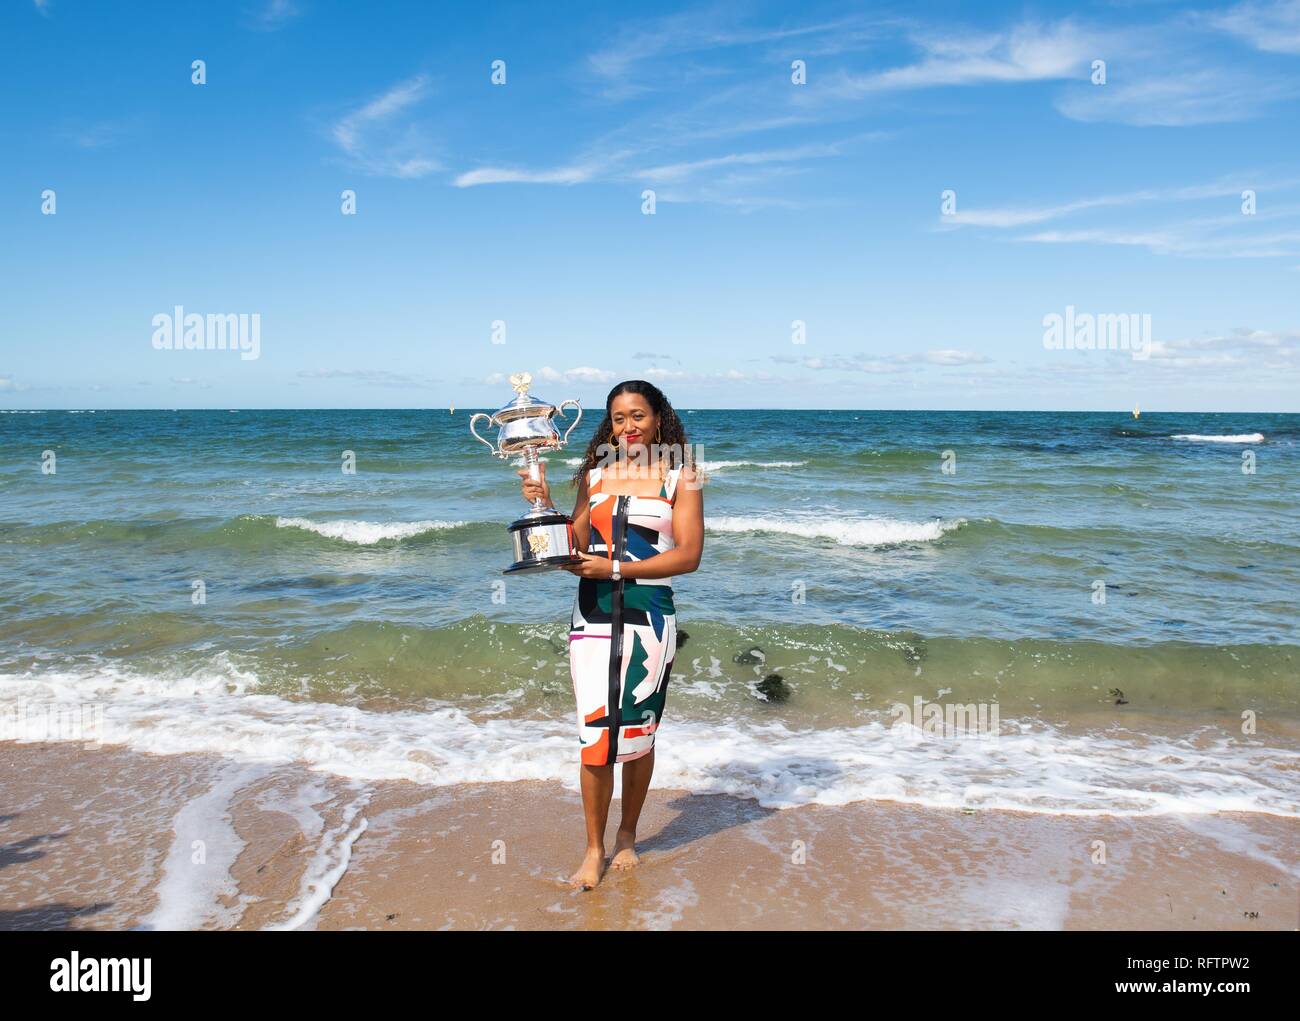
<box><xmin>0</xmin><ymin>657</ymin><xmax>1300</xmax><ymax>822</ymax></box>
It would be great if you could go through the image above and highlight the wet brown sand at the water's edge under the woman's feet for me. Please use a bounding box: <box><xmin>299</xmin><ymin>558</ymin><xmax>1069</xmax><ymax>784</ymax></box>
<box><xmin>0</xmin><ymin>743</ymin><xmax>1300</xmax><ymax>930</ymax></box>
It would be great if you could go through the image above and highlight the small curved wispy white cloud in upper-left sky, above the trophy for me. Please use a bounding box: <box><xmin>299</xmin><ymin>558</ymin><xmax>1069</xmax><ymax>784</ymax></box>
<box><xmin>330</xmin><ymin>74</ymin><xmax>442</xmax><ymax>178</ymax></box>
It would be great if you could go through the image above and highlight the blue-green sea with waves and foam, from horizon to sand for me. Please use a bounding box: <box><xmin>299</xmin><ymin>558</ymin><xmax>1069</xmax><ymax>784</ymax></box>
<box><xmin>0</xmin><ymin>408</ymin><xmax>1300</xmax><ymax>817</ymax></box>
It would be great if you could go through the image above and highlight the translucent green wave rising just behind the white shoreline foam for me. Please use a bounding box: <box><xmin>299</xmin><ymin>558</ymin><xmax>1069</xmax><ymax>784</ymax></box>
<box><xmin>9</xmin><ymin>613</ymin><xmax>1300</xmax><ymax>707</ymax></box>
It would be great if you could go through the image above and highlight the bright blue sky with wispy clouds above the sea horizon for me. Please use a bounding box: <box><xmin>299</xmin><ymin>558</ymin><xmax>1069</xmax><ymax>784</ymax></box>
<box><xmin>0</xmin><ymin>0</ymin><xmax>1300</xmax><ymax>411</ymax></box>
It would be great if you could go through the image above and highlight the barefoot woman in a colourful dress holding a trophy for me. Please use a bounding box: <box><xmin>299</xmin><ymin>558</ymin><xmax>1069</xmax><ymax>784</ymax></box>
<box><xmin>519</xmin><ymin>380</ymin><xmax>705</xmax><ymax>890</ymax></box>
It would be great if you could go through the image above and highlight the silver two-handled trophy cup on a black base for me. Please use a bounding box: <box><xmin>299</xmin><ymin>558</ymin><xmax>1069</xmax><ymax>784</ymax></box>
<box><xmin>469</xmin><ymin>372</ymin><xmax>582</xmax><ymax>575</ymax></box>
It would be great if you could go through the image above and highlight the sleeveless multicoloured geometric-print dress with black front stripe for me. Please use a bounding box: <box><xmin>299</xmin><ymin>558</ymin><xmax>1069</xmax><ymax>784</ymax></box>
<box><xmin>569</xmin><ymin>467</ymin><xmax>681</xmax><ymax>766</ymax></box>
